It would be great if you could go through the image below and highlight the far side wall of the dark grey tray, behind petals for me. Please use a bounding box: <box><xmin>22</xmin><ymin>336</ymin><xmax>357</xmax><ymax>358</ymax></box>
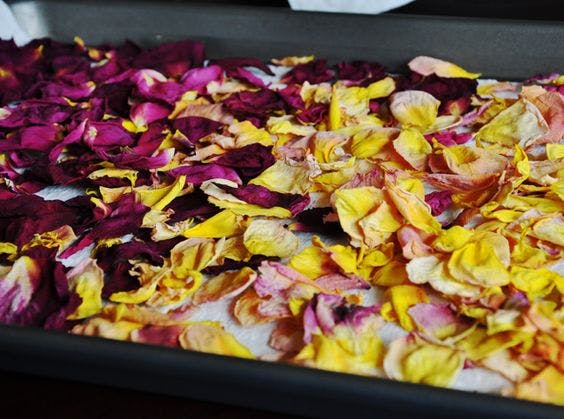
<box><xmin>7</xmin><ymin>0</ymin><xmax>564</xmax><ymax>79</ymax></box>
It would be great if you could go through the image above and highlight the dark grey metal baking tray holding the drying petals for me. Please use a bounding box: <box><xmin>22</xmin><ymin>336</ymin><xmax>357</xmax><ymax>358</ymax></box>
<box><xmin>0</xmin><ymin>0</ymin><xmax>564</xmax><ymax>419</ymax></box>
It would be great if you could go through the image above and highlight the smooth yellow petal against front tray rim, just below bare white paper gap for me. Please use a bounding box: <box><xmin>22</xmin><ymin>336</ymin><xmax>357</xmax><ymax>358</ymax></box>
<box><xmin>178</xmin><ymin>322</ymin><xmax>254</xmax><ymax>359</ymax></box>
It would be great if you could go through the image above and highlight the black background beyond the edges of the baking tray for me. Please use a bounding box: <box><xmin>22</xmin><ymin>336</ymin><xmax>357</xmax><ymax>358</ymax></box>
<box><xmin>0</xmin><ymin>0</ymin><xmax>564</xmax><ymax>419</ymax></box>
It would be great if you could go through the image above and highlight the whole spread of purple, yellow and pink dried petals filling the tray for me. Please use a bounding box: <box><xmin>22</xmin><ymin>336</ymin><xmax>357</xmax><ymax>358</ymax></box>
<box><xmin>0</xmin><ymin>38</ymin><xmax>564</xmax><ymax>404</ymax></box>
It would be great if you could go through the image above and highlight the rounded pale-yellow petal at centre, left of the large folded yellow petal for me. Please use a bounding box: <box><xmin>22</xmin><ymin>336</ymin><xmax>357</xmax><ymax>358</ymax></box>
<box><xmin>243</xmin><ymin>220</ymin><xmax>300</xmax><ymax>258</ymax></box>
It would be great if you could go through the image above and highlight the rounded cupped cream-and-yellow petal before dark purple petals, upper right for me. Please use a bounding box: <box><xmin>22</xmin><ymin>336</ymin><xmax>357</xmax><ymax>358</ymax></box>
<box><xmin>390</xmin><ymin>90</ymin><xmax>441</xmax><ymax>131</ymax></box>
